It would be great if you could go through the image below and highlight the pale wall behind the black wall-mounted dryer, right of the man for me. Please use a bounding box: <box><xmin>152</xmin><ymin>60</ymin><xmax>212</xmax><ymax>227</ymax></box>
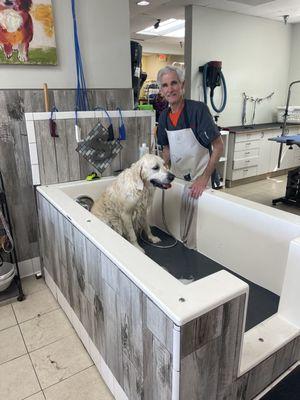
<box><xmin>185</xmin><ymin>6</ymin><xmax>291</xmax><ymax>126</ymax></box>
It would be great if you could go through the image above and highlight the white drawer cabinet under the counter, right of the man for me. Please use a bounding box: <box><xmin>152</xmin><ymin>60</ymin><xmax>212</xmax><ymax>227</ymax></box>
<box><xmin>226</xmin><ymin>126</ymin><xmax>300</xmax><ymax>181</ymax></box>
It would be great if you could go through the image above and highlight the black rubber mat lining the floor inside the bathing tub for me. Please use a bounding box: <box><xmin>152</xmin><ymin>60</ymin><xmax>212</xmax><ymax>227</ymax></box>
<box><xmin>140</xmin><ymin>228</ymin><xmax>278</xmax><ymax>332</ymax></box>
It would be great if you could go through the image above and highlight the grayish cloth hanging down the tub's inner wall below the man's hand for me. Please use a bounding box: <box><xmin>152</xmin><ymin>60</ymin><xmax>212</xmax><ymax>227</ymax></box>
<box><xmin>180</xmin><ymin>183</ymin><xmax>198</xmax><ymax>250</ymax></box>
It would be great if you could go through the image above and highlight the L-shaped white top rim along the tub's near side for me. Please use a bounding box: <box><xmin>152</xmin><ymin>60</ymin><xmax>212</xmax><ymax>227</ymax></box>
<box><xmin>37</xmin><ymin>183</ymin><xmax>249</xmax><ymax>326</ymax></box>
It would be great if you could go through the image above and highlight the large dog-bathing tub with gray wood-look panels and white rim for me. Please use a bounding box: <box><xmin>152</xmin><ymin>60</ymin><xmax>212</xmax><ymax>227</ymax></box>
<box><xmin>37</xmin><ymin>178</ymin><xmax>300</xmax><ymax>400</ymax></box>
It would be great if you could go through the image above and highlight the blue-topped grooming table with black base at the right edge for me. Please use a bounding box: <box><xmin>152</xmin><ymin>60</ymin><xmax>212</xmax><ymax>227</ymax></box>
<box><xmin>269</xmin><ymin>135</ymin><xmax>300</xmax><ymax>207</ymax></box>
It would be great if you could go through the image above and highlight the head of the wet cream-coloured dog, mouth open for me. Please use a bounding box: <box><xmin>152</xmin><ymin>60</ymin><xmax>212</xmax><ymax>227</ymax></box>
<box><xmin>136</xmin><ymin>154</ymin><xmax>175</xmax><ymax>189</ymax></box>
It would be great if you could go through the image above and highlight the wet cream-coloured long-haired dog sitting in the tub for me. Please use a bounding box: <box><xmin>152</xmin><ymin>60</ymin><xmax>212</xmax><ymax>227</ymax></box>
<box><xmin>91</xmin><ymin>154</ymin><xmax>175</xmax><ymax>252</ymax></box>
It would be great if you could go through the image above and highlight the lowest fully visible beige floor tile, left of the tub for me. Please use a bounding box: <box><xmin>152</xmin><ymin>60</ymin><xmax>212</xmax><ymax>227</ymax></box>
<box><xmin>30</xmin><ymin>334</ymin><xmax>93</xmax><ymax>389</ymax></box>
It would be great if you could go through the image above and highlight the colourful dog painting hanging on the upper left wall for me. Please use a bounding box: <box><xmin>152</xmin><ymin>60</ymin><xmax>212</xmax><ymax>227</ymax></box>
<box><xmin>0</xmin><ymin>0</ymin><xmax>57</xmax><ymax>65</ymax></box>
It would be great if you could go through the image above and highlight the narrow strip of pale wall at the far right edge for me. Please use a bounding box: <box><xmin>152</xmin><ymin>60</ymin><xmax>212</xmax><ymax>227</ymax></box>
<box><xmin>284</xmin><ymin>23</ymin><xmax>300</xmax><ymax>106</ymax></box>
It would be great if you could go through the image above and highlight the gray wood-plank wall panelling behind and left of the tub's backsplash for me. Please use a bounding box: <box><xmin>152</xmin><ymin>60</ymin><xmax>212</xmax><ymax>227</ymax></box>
<box><xmin>0</xmin><ymin>88</ymin><xmax>133</xmax><ymax>268</ymax></box>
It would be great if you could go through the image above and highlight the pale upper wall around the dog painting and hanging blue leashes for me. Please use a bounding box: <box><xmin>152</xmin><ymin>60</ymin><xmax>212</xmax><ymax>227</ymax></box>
<box><xmin>0</xmin><ymin>0</ymin><xmax>131</xmax><ymax>89</ymax></box>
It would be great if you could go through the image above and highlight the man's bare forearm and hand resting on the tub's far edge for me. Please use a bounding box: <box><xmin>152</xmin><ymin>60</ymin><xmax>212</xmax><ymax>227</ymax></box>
<box><xmin>189</xmin><ymin>136</ymin><xmax>224</xmax><ymax>199</ymax></box>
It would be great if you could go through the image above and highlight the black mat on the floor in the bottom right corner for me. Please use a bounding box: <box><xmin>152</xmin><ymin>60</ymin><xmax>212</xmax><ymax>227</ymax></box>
<box><xmin>261</xmin><ymin>366</ymin><xmax>300</xmax><ymax>400</ymax></box>
